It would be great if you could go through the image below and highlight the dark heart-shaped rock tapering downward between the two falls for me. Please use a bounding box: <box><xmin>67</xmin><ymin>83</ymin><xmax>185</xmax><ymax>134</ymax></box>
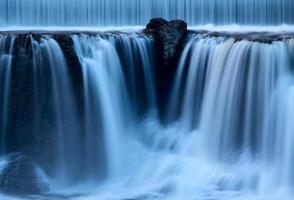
<box><xmin>144</xmin><ymin>18</ymin><xmax>188</xmax><ymax>119</ymax></box>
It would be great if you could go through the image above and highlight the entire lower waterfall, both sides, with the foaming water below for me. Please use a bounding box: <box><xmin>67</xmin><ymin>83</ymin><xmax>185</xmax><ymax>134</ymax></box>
<box><xmin>0</xmin><ymin>33</ymin><xmax>294</xmax><ymax>200</ymax></box>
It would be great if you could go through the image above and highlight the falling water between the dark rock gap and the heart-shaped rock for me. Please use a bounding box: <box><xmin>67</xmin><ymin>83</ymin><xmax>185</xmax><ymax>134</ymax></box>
<box><xmin>73</xmin><ymin>34</ymin><xmax>155</xmax><ymax>179</ymax></box>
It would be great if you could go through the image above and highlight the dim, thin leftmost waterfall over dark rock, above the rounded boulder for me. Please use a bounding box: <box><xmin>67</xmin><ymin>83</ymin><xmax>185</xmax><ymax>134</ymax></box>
<box><xmin>0</xmin><ymin>35</ymin><xmax>85</xmax><ymax>186</ymax></box>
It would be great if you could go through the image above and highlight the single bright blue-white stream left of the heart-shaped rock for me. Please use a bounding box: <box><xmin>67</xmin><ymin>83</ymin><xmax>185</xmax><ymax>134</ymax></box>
<box><xmin>74</xmin><ymin>36</ymin><xmax>129</xmax><ymax>180</ymax></box>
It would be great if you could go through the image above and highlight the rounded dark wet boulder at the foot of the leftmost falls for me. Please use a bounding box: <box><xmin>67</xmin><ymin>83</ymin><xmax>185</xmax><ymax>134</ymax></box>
<box><xmin>0</xmin><ymin>153</ymin><xmax>49</xmax><ymax>195</ymax></box>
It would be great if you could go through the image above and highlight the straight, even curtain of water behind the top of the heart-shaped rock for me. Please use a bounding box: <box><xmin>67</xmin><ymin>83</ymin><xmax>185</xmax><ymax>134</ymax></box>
<box><xmin>0</xmin><ymin>0</ymin><xmax>294</xmax><ymax>27</ymax></box>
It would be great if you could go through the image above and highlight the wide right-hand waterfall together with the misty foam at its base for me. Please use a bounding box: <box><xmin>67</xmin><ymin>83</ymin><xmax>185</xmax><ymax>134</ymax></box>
<box><xmin>74</xmin><ymin>35</ymin><xmax>294</xmax><ymax>200</ymax></box>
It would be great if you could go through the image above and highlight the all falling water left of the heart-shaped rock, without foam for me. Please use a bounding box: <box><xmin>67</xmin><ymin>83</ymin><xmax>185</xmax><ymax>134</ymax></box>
<box><xmin>0</xmin><ymin>33</ymin><xmax>157</xmax><ymax>189</ymax></box>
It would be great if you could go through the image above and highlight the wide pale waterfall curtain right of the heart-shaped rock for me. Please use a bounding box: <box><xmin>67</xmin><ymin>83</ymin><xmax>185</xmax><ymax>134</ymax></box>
<box><xmin>163</xmin><ymin>36</ymin><xmax>294</xmax><ymax>199</ymax></box>
